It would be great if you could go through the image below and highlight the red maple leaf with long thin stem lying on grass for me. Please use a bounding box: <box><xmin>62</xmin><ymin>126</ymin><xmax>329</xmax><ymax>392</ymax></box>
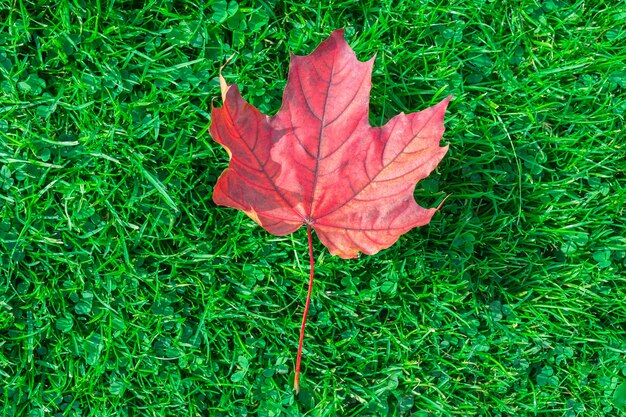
<box><xmin>210</xmin><ymin>29</ymin><xmax>450</xmax><ymax>390</ymax></box>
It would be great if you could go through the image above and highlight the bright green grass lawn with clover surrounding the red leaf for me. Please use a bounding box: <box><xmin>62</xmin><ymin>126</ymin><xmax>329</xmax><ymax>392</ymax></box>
<box><xmin>0</xmin><ymin>0</ymin><xmax>626</xmax><ymax>417</ymax></box>
